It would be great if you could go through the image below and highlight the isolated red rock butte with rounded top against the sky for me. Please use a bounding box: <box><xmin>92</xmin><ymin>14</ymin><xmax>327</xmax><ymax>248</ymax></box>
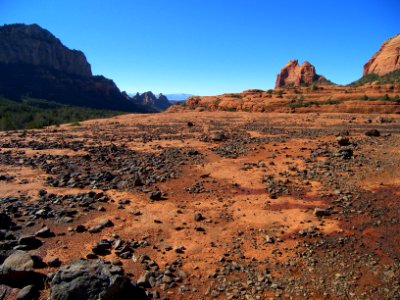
<box><xmin>275</xmin><ymin>60</ymin><xmax>330</xmax><ymax>88</ymax></box>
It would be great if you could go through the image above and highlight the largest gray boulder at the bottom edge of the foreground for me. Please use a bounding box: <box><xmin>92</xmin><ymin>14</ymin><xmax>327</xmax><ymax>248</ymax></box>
<box><xmin>49</xmin><ymin>259</ymin><xmax>147</xmax><ymax>300</ymax></box>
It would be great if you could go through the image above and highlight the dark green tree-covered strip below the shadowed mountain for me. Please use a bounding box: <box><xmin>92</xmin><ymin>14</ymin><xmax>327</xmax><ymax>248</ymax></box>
<box><xmin>0</xmin><ymin>97</ymin><xmax>123</xmax><ymax>130</ymax></box>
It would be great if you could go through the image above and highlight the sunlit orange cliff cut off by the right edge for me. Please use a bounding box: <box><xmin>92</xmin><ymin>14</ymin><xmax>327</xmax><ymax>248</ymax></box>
<box><xmin>363</xmin><ymin>34</ymin><xmax>400</xmax><ymax>76</ymax></box>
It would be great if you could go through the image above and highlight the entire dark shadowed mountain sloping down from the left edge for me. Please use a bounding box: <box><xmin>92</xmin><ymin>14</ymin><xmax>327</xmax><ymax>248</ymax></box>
<box><xmin>0</xmin><ymin>24</ymin><xmax>148</xmax><ymax>112</ymax></box>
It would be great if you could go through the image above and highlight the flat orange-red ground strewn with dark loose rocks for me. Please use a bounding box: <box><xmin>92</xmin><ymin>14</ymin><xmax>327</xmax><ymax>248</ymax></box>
<box><xmin>0</xmin><ymin>112</ymin><xmax>400</xmax><ymax>299</ymax></box>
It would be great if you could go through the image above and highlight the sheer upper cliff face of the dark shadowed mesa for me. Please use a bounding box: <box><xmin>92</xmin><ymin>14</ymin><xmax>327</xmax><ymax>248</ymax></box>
<box><xmin>0</xmin><ymin>24</ymin><xmax>92</xmax><ymax>77</ymax></box>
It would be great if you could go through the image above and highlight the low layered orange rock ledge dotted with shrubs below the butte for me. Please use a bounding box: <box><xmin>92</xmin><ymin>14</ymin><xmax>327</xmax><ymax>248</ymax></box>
<box><xmin>169</xmin><ymin>83</ymin><xmax>400</xmax><ymax>114</ymax></box>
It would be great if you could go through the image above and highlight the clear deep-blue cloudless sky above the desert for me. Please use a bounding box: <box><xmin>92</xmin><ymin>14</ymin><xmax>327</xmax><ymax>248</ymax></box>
<box><xmin>0</xmin><ymin>0</ymin><xmax>400</xmax><ymax>95</ymax></box>
